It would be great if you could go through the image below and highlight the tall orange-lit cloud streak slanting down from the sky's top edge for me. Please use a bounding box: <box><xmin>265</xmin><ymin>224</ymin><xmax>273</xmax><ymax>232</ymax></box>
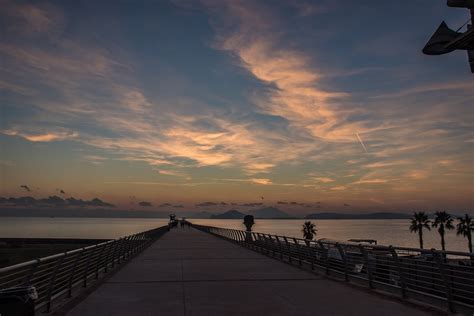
<box><xmin>206</xmin><ymin>2</ymin><xmax>366</xmax><ymax>142</ymax></box>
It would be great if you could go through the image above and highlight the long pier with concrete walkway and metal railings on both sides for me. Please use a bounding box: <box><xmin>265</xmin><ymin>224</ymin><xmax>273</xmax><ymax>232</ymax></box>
<box><xmin>0</xmin><ymin>225</ymin><xmax>474</xmax><ymax>316</ymax></box>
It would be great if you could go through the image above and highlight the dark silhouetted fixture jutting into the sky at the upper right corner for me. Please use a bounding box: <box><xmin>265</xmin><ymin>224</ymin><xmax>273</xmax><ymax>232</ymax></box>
<box><xmin>423</xmin><ymin>0</ymin><xmax>474</xmax><ymax>73</ymax></box>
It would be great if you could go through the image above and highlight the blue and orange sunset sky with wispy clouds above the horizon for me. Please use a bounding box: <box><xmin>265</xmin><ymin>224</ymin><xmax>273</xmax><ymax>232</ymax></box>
<box><xmin>0</xmin><ymin>0</ymin><xmax>474</xmax><ymax>214</ymax></box>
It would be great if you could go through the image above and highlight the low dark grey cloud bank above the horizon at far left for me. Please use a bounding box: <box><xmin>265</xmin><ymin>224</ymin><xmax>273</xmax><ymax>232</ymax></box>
<box><xmin>0</xmin><ymin>195</ymin><xmax>114</xmax><ymax>207</ymax></box>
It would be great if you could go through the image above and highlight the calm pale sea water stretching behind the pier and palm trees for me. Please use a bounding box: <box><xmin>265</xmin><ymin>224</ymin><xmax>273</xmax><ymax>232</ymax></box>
<box><xmin>0</xmin><ymin>217</ymin><xmax>467</xmax><ymax>251</ymax></box>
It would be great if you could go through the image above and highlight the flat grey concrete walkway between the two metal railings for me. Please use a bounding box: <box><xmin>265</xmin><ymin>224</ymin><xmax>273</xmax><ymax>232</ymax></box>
<box><xmin>67</xmin><ymin>228</ymin><xmax>428</xmax><ymax>316</ymax></box>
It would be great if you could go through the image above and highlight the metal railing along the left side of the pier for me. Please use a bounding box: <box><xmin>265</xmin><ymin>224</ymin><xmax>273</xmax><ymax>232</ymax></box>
<box><xmin>0</xmin><ymin>226</ymin><xmax>168</xmax><ymax>312</ymax></box>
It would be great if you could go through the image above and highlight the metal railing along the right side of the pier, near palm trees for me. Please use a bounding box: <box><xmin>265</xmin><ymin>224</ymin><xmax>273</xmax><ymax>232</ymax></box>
<box><xmin>193</xmin><ymin>225</ymin><xmax>474</xmax><ymax>314</ymax></box>
